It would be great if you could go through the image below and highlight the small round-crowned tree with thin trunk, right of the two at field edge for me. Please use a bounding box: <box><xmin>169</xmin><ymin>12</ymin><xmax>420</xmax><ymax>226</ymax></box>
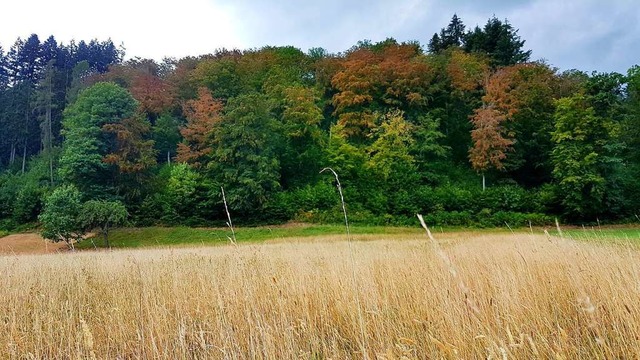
<box><xmin>80</xmin><ymin>200</ymin><xmax>129</xmax><ymax>249</ymax></box>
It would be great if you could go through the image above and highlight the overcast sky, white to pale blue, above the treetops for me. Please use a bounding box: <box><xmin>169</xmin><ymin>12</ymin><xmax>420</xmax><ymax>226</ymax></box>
<box><xmin>0</xmin><ymin>0</ymin><xmax>640</xmax><ymax>73</ymax></box>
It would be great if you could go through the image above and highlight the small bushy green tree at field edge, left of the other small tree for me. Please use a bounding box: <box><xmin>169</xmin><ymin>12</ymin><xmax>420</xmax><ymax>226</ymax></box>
<box><xmin>38</xmin><ymin>185</ymin><xmax>85</xmax><ymax>250</ymax></box>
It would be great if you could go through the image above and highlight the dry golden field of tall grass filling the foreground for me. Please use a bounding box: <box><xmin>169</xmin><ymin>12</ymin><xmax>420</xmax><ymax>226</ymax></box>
<box><xmin>0</xmin><ymin>233</ymin><xmax>640</xmax><ymax>359</ymax></box>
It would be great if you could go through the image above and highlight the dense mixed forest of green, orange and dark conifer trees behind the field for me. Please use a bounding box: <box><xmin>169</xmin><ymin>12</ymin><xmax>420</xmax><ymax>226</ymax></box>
<box><xmin>0</xmin><ymin>15</ymin><xmax>640</xmax><ymax>235</ymax></box>
